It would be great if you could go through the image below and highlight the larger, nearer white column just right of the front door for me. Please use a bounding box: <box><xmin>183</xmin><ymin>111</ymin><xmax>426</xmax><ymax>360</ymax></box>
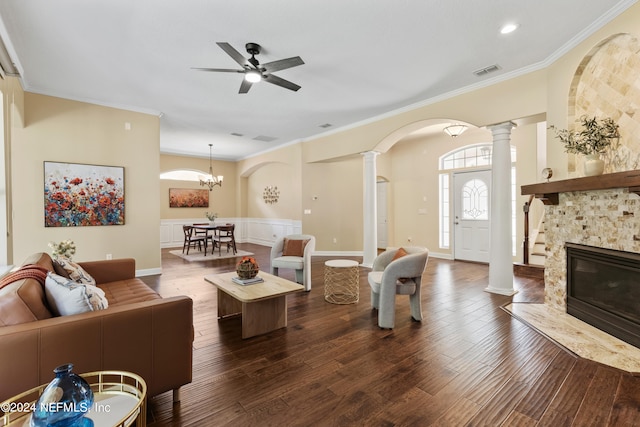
<box><xmin>485</xmin><ymin>122</ymin><xmax>517</xmax><ymax>295</ymax></box>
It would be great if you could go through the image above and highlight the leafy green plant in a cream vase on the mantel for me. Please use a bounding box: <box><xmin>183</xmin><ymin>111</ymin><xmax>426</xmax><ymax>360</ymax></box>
<box><xmin>550</xmin><ymin>115</ymin><xmax>620</xmax><ymax>176</ymax></box>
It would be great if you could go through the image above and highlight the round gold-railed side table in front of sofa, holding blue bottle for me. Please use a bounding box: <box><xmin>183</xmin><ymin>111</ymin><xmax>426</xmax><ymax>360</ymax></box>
<box><xmin>0</xmin><ymin>371</ymin><xmax>147</xmax><ymax>427</ymax></box>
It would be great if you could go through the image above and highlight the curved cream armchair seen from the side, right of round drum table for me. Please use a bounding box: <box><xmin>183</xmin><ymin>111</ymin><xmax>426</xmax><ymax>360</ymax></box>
<box><xmin>368</xmin><ymin>246</ymin><xmax>429</xmax><ymax>329</ymax></box>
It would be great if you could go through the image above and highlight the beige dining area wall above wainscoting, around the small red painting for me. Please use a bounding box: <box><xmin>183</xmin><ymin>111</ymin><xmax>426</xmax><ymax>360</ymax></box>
<box><xmin>159</xmin><ymin>154</ymin><xmax>238</xmax><ymax>221</ymax></box>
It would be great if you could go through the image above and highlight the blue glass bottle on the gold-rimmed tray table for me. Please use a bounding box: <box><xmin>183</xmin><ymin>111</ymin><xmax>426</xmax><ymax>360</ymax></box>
<box><xmin>30</xmin><ymin>363</ymin><xmax>93</xmax><ymax>427</ymax></box>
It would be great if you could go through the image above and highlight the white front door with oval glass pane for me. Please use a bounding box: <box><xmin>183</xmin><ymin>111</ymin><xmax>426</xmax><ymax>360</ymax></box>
<box><xmin>453</xmin><ymin>170</ymin><xmax>491</xmax><ymax>262</ymax></box>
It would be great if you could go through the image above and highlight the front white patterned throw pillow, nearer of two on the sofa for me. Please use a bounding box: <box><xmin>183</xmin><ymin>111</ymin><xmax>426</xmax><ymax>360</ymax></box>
<box><xmin>44</xmin><ymin>273</ymin><xmax>109</xmax><ymax>316</ymax></box>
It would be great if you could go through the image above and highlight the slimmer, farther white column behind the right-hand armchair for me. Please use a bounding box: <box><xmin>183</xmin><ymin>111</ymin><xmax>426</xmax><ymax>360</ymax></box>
<box><xmin>362</xmin><ymin>151</ymin><xmax>380</xmax><ymax>268</ymax></box>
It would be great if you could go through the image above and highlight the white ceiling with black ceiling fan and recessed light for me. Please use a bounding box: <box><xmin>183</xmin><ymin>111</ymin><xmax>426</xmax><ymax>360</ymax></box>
<box><xmin>0</xmin><ymin>0</ymin><xmax>635</xmax><ymax>160</ymax></box>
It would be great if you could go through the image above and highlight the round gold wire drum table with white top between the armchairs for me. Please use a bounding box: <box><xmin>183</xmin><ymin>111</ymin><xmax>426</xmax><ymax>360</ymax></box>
<box><xmin>324</xmin><ymin>259</ymin><xmax>360</xmax><ymax>304</ymax></box>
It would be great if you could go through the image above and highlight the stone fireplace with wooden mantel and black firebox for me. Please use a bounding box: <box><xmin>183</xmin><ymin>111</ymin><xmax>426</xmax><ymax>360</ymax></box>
<box><xmin>522</xmin><ymin>171</ymin><xmax>640</xmax><ymax>347</ymax></box>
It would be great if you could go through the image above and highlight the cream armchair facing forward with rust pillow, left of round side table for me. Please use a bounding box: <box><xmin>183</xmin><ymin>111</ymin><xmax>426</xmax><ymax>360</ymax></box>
<box><xmin>271</xmin><ymin>234</ymin><xmax>316</xmax><ymax>291</ymax></box>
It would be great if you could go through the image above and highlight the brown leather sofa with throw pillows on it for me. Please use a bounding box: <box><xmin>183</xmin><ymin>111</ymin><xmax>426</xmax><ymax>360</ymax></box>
<box><xmin>0</xmin><ymin>253</ymin><xmax>193</xmax><ymax>401</ymax></box>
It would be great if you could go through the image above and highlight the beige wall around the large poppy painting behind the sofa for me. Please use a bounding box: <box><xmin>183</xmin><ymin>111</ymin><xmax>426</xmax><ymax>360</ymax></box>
<box><xmin>11</xmin><ymin>93</ymin><xmax>160</xmax><ymax>270</ymax></box>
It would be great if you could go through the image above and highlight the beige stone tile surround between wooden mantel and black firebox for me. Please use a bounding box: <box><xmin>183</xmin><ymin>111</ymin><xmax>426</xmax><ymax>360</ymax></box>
<box><xmin>544</xmin><ymin>189</ymin><xmax>640</xmax><ymax>312</ymax></box>
